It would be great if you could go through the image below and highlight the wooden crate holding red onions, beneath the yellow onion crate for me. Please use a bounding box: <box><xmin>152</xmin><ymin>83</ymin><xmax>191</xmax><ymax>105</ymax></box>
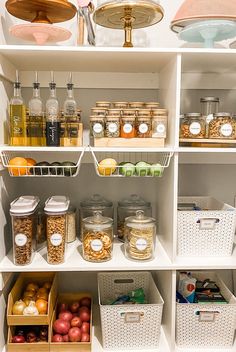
<box><xmin>7</xmin><ymin>326</ymin><xmax>50</xmax><ymax>352</ymax></box>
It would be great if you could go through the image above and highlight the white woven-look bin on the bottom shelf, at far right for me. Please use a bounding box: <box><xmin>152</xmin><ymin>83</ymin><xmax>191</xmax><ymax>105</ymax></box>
<box><xmin>176</xmin><ymin>272</ymin><xmax>236</xmax><ymax>349</ymax></box>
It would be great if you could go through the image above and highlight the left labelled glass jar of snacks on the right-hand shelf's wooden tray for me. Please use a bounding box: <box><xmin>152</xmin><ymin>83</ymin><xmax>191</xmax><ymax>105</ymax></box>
<box><xmin>180</xmin><ymin>112</ymin><xmax>206</xmax><ymax>139</ymax></box>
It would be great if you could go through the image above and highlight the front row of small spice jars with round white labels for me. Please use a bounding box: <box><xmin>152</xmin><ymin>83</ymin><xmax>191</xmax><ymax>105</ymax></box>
<box><xmin>90</xmin><ymin>113</ymin><xmax>167</xmax><ymax>138</ymax></box>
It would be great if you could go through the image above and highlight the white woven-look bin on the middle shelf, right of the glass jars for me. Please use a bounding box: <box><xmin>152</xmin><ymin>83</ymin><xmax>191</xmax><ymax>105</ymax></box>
<box><xmin>178</xmin><ymin>197</ymin><xmax>236</xmax><ymax>257</ymax></box>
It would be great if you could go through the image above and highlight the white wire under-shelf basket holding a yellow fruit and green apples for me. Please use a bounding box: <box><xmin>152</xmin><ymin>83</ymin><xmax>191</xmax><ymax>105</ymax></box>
<box><xmin>90</xmin><ymin>148</ymin><xmax>173</xmax><ymax>177</ymax></box>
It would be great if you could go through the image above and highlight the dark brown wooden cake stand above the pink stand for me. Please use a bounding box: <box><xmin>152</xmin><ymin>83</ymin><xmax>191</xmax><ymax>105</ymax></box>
<box><xmin>6</xmin><ymin>0</ymin><xmax>77</xmax><ymax>24</ymax></box>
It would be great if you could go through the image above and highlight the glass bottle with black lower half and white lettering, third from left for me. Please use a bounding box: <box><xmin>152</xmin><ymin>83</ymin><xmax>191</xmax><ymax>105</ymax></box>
<box><xmin>46</xmin><ymin>73</ymin><xmax>61</xmax><ymax>147</ymax></box>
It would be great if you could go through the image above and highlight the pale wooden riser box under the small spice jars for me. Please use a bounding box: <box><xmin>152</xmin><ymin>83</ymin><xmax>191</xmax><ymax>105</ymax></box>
<box><xmin>94</xmin><ymin>138</ymin><xmax>165</xmax><ymax>148</ymax></box>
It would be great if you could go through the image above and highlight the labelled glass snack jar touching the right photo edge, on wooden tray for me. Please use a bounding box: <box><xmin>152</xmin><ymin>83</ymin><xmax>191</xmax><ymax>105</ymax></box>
<box><xmin>209</xmin><ymin>112</ymin><xmax>236</xmax><ymax>139</ymax></box>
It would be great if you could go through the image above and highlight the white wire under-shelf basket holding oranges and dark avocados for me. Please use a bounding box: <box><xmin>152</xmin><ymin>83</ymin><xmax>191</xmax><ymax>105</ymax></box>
<box><xmin>0</xmin><ymin>150</ymin><xmax>85</xmax><ymax>177</ymax></box>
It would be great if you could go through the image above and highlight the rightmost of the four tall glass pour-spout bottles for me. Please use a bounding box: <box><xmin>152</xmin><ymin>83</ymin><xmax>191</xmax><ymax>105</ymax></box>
<box><xmin>63</xmin><ymin>73</ymin><xmax>79</xmax><ymax>147</ymax></box>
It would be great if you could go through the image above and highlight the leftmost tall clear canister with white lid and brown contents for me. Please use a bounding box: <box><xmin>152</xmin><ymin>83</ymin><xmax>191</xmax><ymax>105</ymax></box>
<box><xmin>10</xmin><ymin>196</ymin><xmax>39</xmax><ymax>265</ymax></box>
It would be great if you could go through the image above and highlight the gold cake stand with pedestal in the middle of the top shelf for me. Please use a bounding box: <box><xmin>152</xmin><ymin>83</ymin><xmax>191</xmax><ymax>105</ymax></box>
<box><xmin>93</xmin><ymin>0</ymin><xmax>164</xmax><ymax>48</ymax></box>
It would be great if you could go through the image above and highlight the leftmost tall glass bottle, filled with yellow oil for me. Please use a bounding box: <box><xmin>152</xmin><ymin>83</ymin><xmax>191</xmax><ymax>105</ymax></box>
<box><xmin>9</xmin><ymin>71</ymin><xmax>27</xmax><ymax>146</ymax></box>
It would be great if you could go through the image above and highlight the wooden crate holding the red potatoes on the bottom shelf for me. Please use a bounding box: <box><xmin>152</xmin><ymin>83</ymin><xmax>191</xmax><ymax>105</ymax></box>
<box><xmin>49</xmin><ymin>293</ymin><xmax>92</xmax><ymax>352</ymax></box>
